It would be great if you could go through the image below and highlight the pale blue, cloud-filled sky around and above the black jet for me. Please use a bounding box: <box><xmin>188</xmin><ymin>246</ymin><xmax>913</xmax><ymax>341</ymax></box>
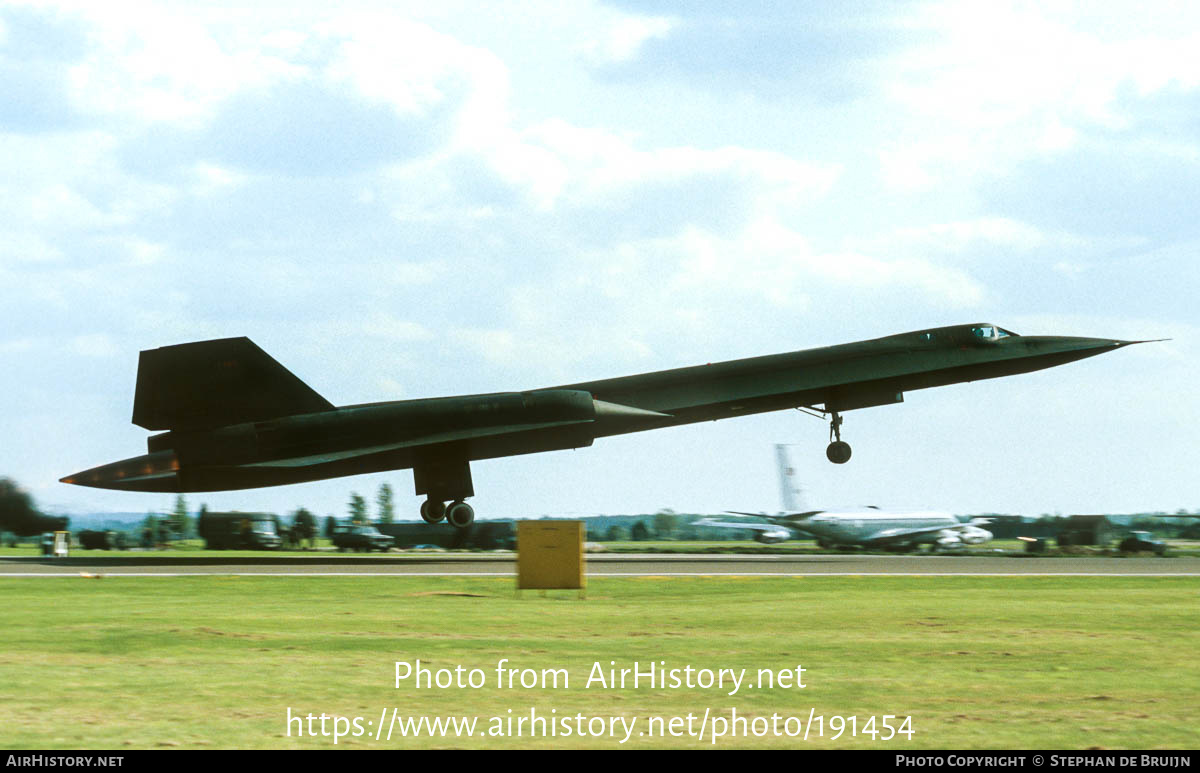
<box><xmin>0</xmin><ymin>0</ymin><xmax>1200</xmax><ymax>517</ymax></box>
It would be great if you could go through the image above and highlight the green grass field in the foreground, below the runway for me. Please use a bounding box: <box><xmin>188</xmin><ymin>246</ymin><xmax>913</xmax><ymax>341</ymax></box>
<box><xmin>0</xmin><ymin>576</ymin><xmax>1200</xmax><ymax>749</ymax></box>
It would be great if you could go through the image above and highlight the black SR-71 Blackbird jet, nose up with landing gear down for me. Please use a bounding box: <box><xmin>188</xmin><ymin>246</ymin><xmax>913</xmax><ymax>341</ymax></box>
<box><xmin>61</xmin><ymin>324</ymin><xmax>1141</xmax><ymax>528</ymax></box>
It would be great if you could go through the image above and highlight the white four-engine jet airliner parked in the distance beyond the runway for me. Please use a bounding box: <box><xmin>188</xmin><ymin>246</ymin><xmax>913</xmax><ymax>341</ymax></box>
<box><xmin>694</xmin><ymin>445</ymin><xmax>991</xmax><ymax>550</ymax></box>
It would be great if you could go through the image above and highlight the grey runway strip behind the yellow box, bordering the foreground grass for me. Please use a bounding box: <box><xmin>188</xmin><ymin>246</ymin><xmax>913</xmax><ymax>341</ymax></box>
<box><xmin>0</xmin><ymin>553</ymin><xmax>1200</xmax><ymax>577</ymax></box>
